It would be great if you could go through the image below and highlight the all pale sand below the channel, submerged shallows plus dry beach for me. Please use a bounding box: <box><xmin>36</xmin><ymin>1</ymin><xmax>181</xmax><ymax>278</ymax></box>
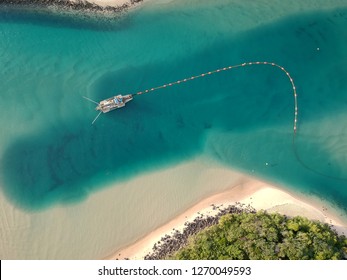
<box><xmin>0</xmin><ymin>154</ymin><xmax>347</xmax><ymax>259</ymax></box>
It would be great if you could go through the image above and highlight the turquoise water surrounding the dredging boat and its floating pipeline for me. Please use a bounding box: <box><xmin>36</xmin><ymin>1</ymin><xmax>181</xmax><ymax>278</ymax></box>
<box><xmin>0</xmin><ymin>1</ymin><xmax>347</xmax><ymax>214</ymax></box>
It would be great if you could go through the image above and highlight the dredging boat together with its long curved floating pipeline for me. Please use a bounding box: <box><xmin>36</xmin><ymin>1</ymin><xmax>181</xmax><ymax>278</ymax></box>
<box><xmin>83</xmin><ymin>61</ymin><xmax>347</xmax><ymax>181</ymax></box>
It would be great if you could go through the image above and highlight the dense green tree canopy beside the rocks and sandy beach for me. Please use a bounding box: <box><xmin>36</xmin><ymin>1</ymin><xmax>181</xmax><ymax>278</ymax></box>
<box><xmin>146</xmin><ymin>208</ymin><xmax>347</xmax><ymax>260</ymax></box>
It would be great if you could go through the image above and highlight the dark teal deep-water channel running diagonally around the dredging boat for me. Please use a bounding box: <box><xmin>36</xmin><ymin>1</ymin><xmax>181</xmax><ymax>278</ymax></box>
<box><xmin>1</xmin><ymin>6</ymin><xmax>347</xmax><ymax>209</ymax></box>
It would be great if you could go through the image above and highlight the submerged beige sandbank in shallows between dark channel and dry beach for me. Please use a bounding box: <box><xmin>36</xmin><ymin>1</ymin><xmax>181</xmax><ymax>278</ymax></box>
<box><xmin>0</xmin><ymin>158</ymin><xmax>250</xmax><ymax>259</ymax></box>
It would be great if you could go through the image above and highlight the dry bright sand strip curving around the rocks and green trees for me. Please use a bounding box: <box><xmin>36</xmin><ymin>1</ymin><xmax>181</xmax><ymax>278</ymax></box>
<box><xmin>110</xmin><ymin>179</ymin><xmax>347</xmax><ymax>260</ymax></box>
